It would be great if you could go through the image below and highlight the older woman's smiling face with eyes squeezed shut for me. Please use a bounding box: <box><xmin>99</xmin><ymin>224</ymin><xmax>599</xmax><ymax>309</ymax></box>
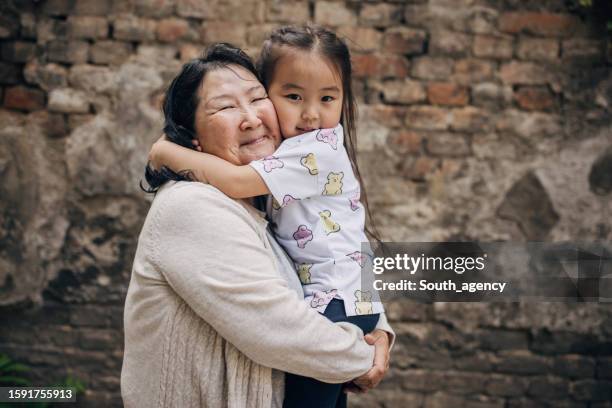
<box><xmin>195</xmin><ymin>65</ymin><xmax>280</xmax><ymax>165</ymax></box>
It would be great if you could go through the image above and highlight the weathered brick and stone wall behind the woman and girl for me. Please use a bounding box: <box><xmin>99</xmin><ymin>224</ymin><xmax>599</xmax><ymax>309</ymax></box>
<box><xmin>0</xmin><ymin>0</ymin><xmax>612</xmax><ymax>408</ymax></box>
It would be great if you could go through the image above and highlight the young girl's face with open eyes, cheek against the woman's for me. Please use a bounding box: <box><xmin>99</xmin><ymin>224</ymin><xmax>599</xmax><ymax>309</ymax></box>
<box><xmin>268</xmin><ymin>50</ymin><xmax>343</xmax><ymax>138</ymax></box>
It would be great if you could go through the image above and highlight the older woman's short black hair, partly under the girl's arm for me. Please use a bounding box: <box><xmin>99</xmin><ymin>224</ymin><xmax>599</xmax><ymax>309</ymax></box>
<box><xmin>140</xmin><ymin>43</ymin><xmax>259</xmax><ymax>193</ymax></box>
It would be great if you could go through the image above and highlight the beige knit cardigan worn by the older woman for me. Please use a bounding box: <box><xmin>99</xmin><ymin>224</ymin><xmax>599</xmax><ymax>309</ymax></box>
<box><xmin>121</xmin><ymin>182</ymin><xmax>391</xmax><ymax>408</ymax></box>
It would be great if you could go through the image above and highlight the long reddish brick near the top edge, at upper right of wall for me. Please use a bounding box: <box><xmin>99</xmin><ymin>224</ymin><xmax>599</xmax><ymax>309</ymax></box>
<box><xmin>499</xmin><ymin>12</ymin><xmax>580</xmax><ymax>37</ymax></box>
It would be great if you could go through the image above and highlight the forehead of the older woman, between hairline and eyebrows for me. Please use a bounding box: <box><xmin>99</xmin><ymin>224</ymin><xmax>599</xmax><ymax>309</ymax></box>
<box><xmin>198</xmin><ymin>65</ymin><xmax>263</xmax><ymax>105</ymax></box>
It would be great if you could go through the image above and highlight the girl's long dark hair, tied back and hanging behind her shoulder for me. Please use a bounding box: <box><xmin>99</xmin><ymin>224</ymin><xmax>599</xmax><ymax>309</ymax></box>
<box><xmin>257</xmin><ymin>25</ymin><xmax>380</xmax><ymax>243</ymax></box>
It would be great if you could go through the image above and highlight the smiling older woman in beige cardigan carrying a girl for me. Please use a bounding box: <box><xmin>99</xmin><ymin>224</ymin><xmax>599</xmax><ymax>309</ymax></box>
<box><xmin>121</xmin><ymin>44</ymin><xmax>393</xmax><ymax>408</ymax></box>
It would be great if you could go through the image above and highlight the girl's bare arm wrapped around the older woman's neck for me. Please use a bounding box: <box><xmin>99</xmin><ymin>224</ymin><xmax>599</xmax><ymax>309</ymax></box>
<box><xmin>149</xmin><ymin>139</ymin><xmax>270</xmax><ymax>199</ymax></box>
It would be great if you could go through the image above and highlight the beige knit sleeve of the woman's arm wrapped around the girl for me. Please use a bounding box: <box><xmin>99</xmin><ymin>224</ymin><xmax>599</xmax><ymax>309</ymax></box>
<box><xmin>154</xmin><ymin>183</ymin><xmax>374</xmax><ymax>383</ymax></box>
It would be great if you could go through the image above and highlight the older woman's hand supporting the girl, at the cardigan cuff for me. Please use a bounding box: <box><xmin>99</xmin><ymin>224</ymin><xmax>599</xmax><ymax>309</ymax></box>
<box><xmin>344</xmin><ymin>329</ymin><xmax>389</xmax><ymax>394</ymax></box>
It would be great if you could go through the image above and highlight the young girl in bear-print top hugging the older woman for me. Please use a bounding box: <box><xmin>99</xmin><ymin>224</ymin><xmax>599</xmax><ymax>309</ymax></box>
<box><xmin>151</xmin><ymin>26</ymin><xmax>383</xmax><ymax>407</ymax></box>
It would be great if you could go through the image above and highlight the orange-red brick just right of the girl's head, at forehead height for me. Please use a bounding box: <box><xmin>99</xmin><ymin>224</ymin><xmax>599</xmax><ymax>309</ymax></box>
<box><xmin>352</xmin><ymin>53</ymin><xmax>409</xmax><ymax>78</ymax></box>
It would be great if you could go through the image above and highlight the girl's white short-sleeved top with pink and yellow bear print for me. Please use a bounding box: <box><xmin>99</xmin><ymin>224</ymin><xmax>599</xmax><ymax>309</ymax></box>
<box><xmin>250</xmin><ymin>125</ymin><xmax>383</xmax><ymax>316</ymax></box>
